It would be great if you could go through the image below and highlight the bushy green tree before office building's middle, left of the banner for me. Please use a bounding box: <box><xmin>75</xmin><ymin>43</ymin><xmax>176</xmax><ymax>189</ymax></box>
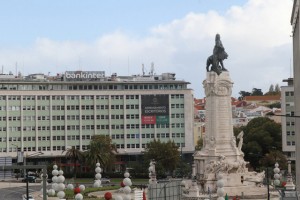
<box><xmin>85</xmin><ymin>135</ymin><xmax>117</xmax><ymax>169</ymax></box>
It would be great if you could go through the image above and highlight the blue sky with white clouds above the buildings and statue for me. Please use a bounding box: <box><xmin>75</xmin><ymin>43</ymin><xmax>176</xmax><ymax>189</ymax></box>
<box><xmin>0</xmin><ymin>0</ymin><xmax>293</xmax><ymax>98</ymax></box>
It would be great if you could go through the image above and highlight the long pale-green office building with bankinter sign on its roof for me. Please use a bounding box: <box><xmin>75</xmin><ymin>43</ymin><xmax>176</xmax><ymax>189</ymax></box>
<box><xmin>0</xmin><ymin>71</ymin><xmax>194</xmax><ymax>166</ymax></box>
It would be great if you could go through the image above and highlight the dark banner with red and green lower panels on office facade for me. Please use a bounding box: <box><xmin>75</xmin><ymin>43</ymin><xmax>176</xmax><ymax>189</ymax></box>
<box><xmin>142</xmin><ymin>95</ymin><xmax>169</xmax><ymax>124</ymax></box>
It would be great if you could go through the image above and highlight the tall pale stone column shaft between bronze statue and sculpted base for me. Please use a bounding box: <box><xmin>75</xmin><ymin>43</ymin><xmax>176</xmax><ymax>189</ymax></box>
<box><xmin>203</xmin><ymin>71</ymin><xmax>237</xmax><ymax>156</ymax></box>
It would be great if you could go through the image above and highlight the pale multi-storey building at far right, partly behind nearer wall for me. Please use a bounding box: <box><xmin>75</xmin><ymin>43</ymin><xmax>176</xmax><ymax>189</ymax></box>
<box><xmin>281</xmin><ymin>78</ymin><xmax>296</xmax><ymax>160</ymax></box>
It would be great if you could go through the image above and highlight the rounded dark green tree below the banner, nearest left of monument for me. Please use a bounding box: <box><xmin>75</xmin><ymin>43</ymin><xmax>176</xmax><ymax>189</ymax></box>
<box><xmin>143</xmin><ymin>140</ymin><xmax>180</xmax><ymax>176</ymax></box>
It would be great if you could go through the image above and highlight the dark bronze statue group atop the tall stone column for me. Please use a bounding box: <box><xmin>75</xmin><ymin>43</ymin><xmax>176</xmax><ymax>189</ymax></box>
<box><xmin>206</xmin><ymin>34</ymin><xmax>228</xmax><ymax>75</ymax></box>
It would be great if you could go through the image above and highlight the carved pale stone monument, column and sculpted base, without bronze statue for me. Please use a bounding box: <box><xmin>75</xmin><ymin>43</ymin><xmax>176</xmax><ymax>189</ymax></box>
<box><xmin>194</xmin><ymin>71</ymin><xmax>267</xmax><ymax>196</ymax></box>
